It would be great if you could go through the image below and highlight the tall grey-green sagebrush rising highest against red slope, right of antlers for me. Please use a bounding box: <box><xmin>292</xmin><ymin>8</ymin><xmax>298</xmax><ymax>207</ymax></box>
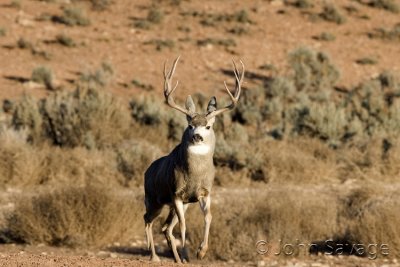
<box><xmin>289</xmin><ymin>47</ymin><xmax>340</xmax><ymax>91</ymax></box>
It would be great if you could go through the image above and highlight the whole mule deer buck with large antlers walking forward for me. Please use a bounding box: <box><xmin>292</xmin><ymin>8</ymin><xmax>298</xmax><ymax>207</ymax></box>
<box><xmin>144</xmin><ymin>57</ymin><xmax>244</xmax><ymax>263</ymax></box>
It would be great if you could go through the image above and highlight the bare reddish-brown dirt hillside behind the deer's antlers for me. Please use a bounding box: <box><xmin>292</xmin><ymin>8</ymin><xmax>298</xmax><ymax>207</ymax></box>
<box><xmin>0</xmin><ymin>0</ymin><xmax>400</xmax><ymax>99</ymax></box>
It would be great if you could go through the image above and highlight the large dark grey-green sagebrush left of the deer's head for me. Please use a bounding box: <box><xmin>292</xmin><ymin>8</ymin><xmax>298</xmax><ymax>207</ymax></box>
<box><xmin>41</xmin><ymin>88</ymin><xmax>129</xmax><ymax>148</ymax></box>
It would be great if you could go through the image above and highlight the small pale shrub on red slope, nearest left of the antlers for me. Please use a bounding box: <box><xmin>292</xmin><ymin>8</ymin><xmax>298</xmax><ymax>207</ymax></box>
<box><xmin>80</xmin><ymin>62</ymin><xmax>114</xmax><ymax>89</ymax></box>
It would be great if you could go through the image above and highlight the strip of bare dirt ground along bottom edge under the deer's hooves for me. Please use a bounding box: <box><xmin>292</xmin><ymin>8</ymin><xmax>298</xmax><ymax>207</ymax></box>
<box><xmin>0</xmin><ymin>246</ymin><xmax>399</xmax><ymax>267</ymax></box>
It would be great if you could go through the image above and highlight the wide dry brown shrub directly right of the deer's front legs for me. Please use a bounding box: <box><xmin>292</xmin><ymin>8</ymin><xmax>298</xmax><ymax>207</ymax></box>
<box><xmin>187</xmin><ymin>187</ymin><xmax>342</xmax><ymax>261</ymax></box>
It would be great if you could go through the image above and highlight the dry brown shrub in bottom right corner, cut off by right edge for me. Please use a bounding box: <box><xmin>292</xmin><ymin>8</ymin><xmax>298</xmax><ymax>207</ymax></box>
<box><xmin>340</xmin><ymin>183</ymin><xmax>400</xmax><ymax>257</ymax></box>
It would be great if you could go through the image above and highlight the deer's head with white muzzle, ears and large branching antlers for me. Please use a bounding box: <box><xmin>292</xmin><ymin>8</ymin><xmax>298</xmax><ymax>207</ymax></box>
<box><xmin>164</xmin><ymin>57</ymin><xmax>244</xmax><ymax>150</ymax></box>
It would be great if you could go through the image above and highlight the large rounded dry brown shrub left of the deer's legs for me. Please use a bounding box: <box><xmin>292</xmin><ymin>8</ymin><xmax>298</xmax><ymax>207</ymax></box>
<box><xmin>7</xmin><ymin>186</ymin><xmax>143</xmax><ymax>246</ymax></box>
